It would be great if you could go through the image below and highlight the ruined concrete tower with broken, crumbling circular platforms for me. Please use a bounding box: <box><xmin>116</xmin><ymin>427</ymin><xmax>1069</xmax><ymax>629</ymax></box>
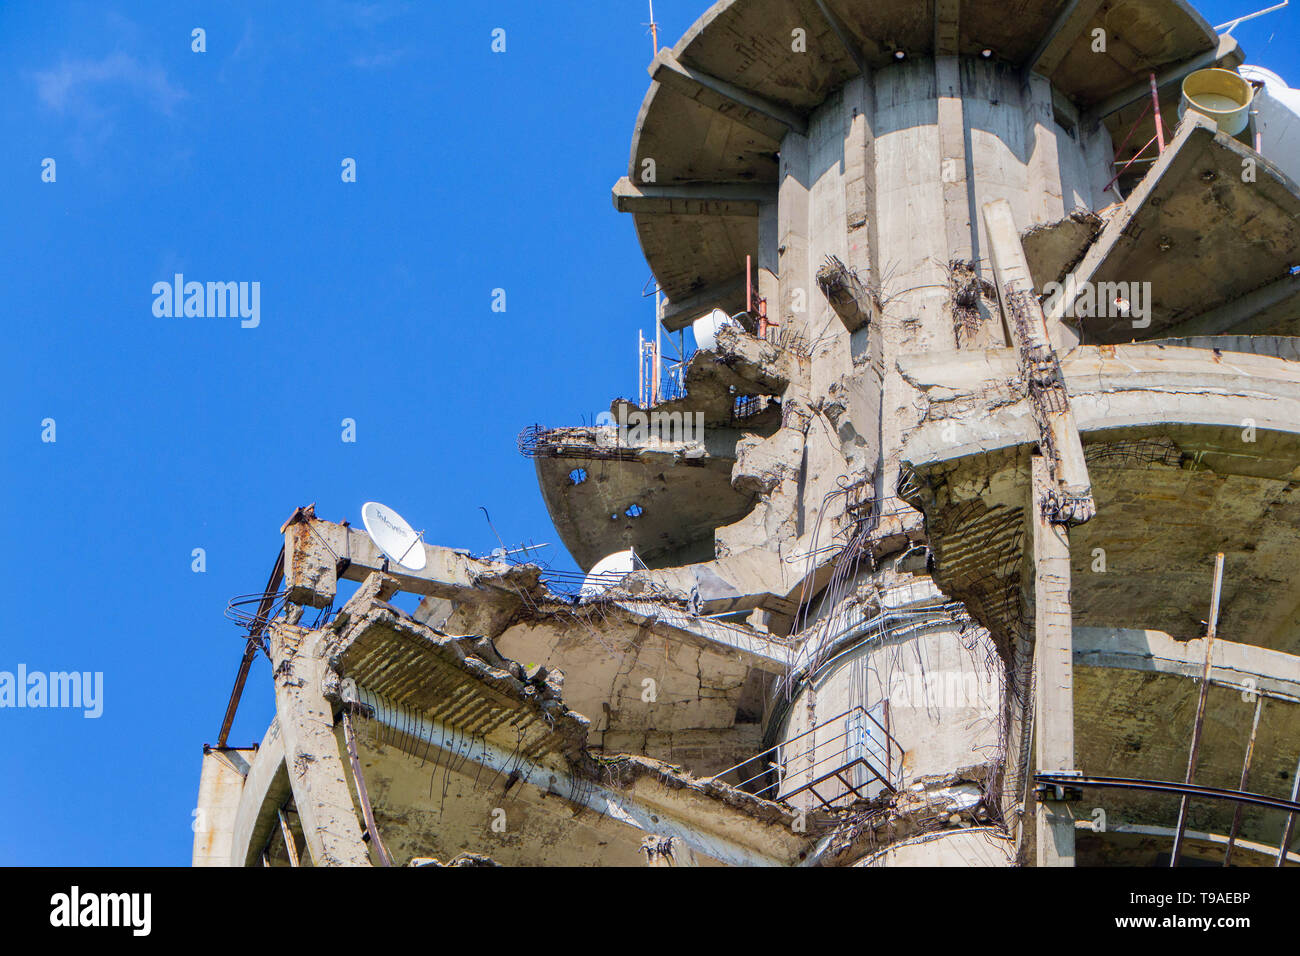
<box><xmin>195</xmin><ymin>0</ymin><xmax>1300</xmax><ymax>866</ymax></box>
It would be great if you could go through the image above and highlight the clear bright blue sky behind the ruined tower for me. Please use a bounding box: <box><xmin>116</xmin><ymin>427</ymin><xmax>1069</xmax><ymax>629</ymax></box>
<box><xmin>0</xmin><ymin>0</ymin><xmax>1300</xmax><ymax>865</ymax></box>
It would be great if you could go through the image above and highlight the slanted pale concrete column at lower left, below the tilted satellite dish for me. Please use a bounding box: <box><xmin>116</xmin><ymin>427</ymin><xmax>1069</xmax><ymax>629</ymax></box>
<box><xmin>270</xmin><ymin>623</ymin><xmax>371</xmax><ymax>866</ymax></box>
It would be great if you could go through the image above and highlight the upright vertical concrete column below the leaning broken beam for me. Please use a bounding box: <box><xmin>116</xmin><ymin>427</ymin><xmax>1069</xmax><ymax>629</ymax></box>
<box><xmin>1030</xmin><ymin>455</ymin><xmax>1075</xmax><ymax>866</ymax></box>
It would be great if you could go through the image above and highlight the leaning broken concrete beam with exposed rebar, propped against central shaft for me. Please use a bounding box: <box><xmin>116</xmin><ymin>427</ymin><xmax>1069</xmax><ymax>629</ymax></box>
<box><xmin>984</xmin><ymin>199</ymin><xmax>1097</xmax><ymax>524</ymax></box>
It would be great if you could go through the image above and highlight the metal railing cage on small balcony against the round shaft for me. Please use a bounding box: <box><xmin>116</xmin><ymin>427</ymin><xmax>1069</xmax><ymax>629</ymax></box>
<box><xmin>712</xmin><ymin>701</ymin><xmax>904</xmax><ymax>810</ymax></box>
